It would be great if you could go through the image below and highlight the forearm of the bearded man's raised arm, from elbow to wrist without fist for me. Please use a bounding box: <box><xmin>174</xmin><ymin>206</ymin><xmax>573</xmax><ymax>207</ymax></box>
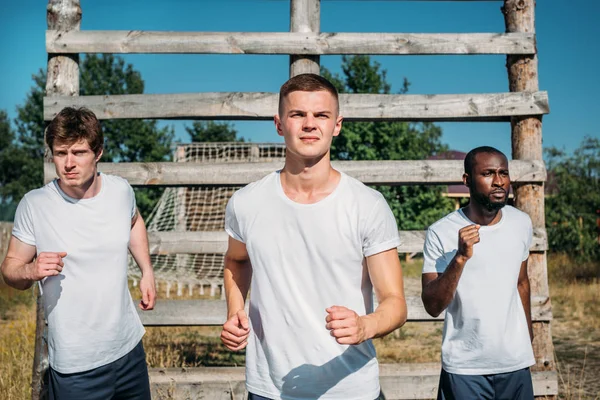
<box><xmin>421</xmin><ymin>256</ymin><xmax>467</xmax><ymax>317</ymax></box>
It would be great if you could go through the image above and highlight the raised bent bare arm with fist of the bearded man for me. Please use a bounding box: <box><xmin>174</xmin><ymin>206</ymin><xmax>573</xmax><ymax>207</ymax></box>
<box><xmin>421</xmin><ymin>225</ymin><xmax>479</xmax><ymax>317</ymax></box>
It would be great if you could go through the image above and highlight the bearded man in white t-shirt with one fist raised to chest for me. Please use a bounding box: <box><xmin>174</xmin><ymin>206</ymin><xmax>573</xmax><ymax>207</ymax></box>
<box><xmin>422</xmin><ymin>146</ymin><xmax>535</xmax><ymax>400</ymax></box>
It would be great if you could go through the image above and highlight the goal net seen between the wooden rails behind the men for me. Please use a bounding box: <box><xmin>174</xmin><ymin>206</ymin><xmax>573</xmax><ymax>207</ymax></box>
<box><xmin>129</xmin><ymin>142</ymin><xmax>285</xmax><ymax>296</ymax></box>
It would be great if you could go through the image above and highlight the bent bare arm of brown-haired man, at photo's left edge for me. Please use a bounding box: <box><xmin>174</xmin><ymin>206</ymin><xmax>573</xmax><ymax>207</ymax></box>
<box><xmin>0</xmin><ymin>236</ymin><xmax>67</xmax><ymax>290</ymax></box>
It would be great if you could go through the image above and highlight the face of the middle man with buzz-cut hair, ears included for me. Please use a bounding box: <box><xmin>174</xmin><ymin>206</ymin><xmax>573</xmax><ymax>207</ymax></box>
<box><xmin>275</xmin><ymin>90</ymin><xmax>342</xmax><ymax>159</ymax></box>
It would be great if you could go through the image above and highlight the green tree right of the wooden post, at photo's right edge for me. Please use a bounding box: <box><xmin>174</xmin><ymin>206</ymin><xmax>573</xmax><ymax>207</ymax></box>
<box><xmin>545</xmin><ymin>137</ymin><xmax>600</xmax><ymax>261</ymax></box>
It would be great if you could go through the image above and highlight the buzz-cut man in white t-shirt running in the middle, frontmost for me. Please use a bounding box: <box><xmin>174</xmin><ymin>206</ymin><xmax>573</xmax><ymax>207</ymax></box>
<box><xmin>221</xmin><ymin>74</ymin><xmax>406</xmax><ymax>400</ymax></box>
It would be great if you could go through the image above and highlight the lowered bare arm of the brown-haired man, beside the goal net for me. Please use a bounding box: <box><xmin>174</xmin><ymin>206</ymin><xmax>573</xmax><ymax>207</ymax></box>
<box><xmin>129</xmin><ymin>210</ymin><xmax>156</xmax><ymax>310</ymax></box>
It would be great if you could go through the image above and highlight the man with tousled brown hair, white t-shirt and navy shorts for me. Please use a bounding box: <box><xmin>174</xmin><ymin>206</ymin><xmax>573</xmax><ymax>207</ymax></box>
<box><xmin>1</xmin><ymin>107</ymin><xmax>156</xmax><ymax>400</ymax></box>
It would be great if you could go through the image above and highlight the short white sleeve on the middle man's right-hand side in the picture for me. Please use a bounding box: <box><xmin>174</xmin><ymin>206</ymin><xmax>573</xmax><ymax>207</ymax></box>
<box><xmin>362</xmin><ymin>196</ymin><xmax>400</xmax><ymax>257</ymax></box>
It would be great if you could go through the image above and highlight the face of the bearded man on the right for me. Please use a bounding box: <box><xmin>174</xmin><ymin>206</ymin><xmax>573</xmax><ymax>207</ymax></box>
<box><xmin>463</xmin><ymin>153</ymin><xmax>510</xmax><ymax>211</ymax></box>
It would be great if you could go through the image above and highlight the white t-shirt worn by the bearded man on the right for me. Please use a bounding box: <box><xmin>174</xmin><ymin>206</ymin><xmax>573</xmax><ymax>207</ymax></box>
<box><xmin>423</xmin><ymin>206</ymin><xmax>535</xmax><ymax>375</ymax></box>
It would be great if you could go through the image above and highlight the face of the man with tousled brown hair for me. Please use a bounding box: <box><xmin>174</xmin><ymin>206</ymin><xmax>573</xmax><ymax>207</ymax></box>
<box><xmin>52</xmin><ymin>139</ymin><xmax>102</xmax><ymax>189</ymax></box>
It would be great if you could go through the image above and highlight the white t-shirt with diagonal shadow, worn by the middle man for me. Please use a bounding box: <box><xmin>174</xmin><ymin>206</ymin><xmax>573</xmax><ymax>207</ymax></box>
<box><xmin>225</xmin><ymin>172</ymin><xmax>400</xmax><ymax>400</ymax></box>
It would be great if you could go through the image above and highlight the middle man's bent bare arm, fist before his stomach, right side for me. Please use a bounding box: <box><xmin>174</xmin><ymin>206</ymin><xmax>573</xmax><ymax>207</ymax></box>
<box><xmin>326</xmin><ymin>248</ymin><xmax>407</xmax><ymax>344</ymax></box>
